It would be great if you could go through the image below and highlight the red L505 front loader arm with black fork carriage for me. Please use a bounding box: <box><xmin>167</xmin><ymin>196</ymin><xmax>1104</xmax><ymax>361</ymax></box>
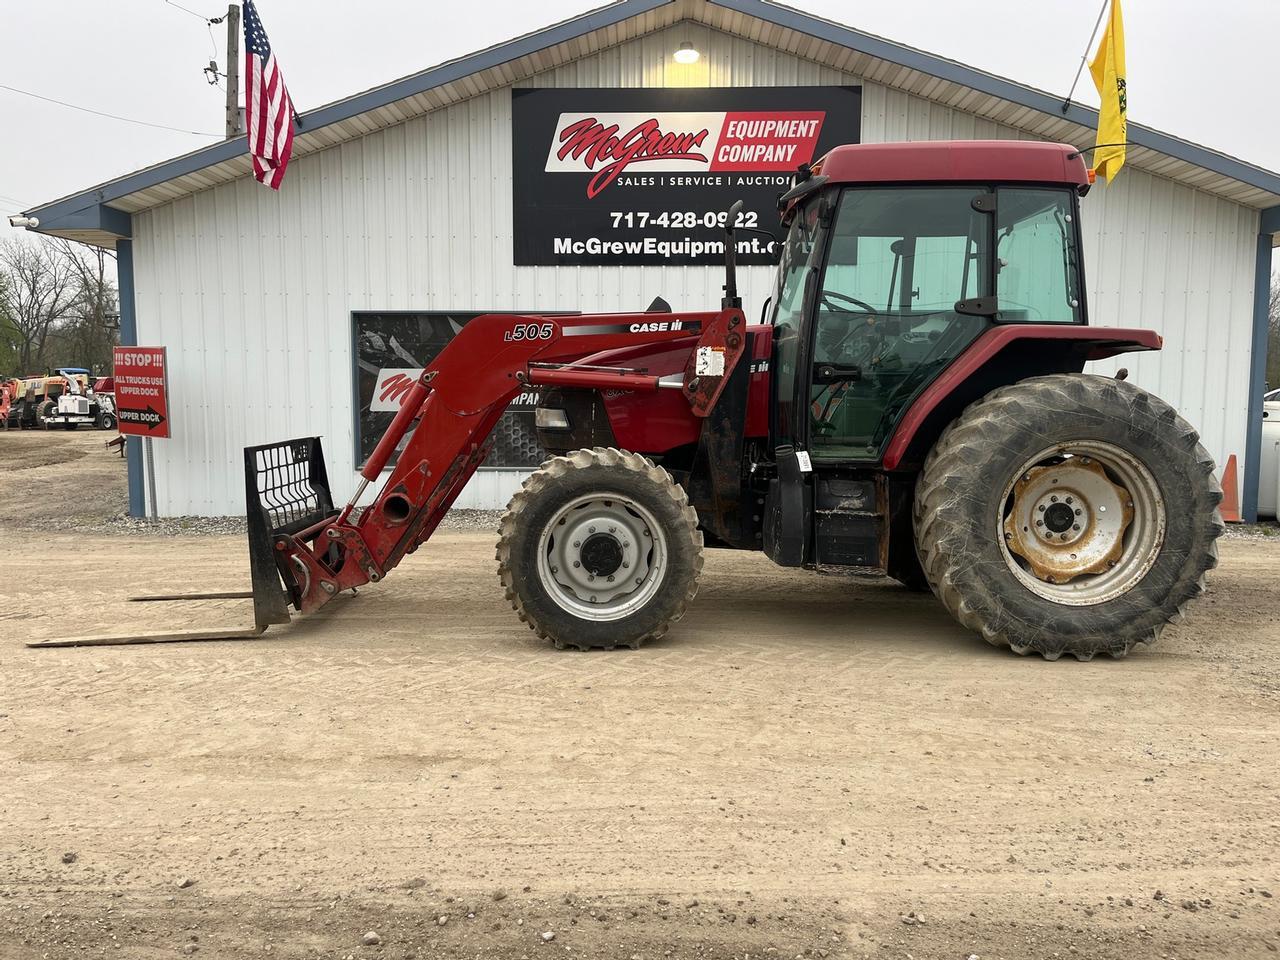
<box><xmin>247</xmin><ymin>307</ymin><xmax>745</xmax><ymax>626</ymax></box>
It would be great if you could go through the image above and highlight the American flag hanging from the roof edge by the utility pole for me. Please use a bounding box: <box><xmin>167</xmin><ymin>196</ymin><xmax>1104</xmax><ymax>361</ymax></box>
<box><xmin>244</xmin><ymin>0</ymin><xmax>293</xmax><ymax>189</ymax></box>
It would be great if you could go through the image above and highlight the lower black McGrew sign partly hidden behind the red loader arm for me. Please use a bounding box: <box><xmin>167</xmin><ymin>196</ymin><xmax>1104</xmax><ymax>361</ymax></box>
<box><xmin>352</xmin><ymin>311</ymin><xmax>547</xmax><ymax>470</ymax></box>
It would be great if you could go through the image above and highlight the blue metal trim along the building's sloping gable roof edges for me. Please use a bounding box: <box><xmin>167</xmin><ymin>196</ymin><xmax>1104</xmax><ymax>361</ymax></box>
<box><xmin>17</xmin><ymin>0</ymin><xmax>1280</xmax><ymax>228</ymax></box>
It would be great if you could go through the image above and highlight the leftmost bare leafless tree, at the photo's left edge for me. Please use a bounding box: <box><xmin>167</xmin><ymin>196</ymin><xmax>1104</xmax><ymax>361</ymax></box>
<box><xmin>0</xmin><ymin>237</ymin><xmax>79</xmax><ymax>374</ymax></box>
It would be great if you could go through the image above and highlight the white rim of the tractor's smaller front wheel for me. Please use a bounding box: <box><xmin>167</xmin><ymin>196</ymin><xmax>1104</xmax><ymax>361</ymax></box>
<box><xmin>538</xmin><ymin>493</ymin><xmax>668</xmax><ymax>622</ymax></box>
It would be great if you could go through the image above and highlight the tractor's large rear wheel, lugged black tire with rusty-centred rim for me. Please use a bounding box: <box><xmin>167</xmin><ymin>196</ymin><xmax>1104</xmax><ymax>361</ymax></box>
<box><xmin>914</xmin><ymin>374</ymin><xmax>1224</xmax><ymax>660</ymax></box>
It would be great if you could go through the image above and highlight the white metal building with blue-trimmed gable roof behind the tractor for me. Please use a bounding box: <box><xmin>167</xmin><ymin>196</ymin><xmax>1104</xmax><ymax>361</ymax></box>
<box><xmin>28</xmin><ymin>0</ymin><xmax>1280</xmax><ymax>516</ymax></box>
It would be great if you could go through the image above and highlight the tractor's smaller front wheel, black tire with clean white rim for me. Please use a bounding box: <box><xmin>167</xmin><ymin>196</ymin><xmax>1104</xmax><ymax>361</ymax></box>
<box><xmin>498</xmin><ymin>447</ymin><xmax>703</xmax><ymax>650</ymax></box>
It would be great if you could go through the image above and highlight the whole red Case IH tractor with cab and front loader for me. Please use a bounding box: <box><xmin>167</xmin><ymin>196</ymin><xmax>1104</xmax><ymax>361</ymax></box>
<box><xmin>49</xmin><ymin>142</ymin><xmax>1222</xmax><ymax>659</ymax></box>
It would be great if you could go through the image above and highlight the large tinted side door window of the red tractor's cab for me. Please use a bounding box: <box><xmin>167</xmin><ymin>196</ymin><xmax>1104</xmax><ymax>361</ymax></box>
<box><xmin>809</xmin><ymin>186</ymin><xmax>993</xmax><ymax>460</ymax></box>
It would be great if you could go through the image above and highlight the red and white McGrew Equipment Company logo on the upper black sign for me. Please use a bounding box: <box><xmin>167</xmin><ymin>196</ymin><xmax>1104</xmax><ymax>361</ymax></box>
<box><xmin>544</xmin><ymin>110</ymin><xmax>826</xmax><ymax>197</ymax></box>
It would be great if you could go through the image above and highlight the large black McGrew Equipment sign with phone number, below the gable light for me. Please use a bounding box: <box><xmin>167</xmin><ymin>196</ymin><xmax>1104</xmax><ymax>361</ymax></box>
<box><xmin>512</xmin><ymin>87</ymin><xmax>861</xmax><ymax>266</ymax></box>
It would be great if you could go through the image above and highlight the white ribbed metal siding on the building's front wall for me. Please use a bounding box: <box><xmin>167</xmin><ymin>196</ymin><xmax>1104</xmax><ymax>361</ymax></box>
<box><xmin>134</xmin><ymin>23</ymin><xmax>1257</xmax><ymax>515</ymax></box>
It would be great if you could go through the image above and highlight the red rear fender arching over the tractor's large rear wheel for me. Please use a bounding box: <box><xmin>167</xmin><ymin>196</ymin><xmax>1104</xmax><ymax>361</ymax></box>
<box><xmin>883</xmin><ymin>324</ymin><xmax>1164</xmax><ymax>471</ymax></box>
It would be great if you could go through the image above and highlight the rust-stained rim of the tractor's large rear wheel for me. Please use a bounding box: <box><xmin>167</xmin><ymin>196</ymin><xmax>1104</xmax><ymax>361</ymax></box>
<box><xmin>996</xmin><ymin>440</ymin><xmax>1166</xmax><ymax>607</ymax></box>
